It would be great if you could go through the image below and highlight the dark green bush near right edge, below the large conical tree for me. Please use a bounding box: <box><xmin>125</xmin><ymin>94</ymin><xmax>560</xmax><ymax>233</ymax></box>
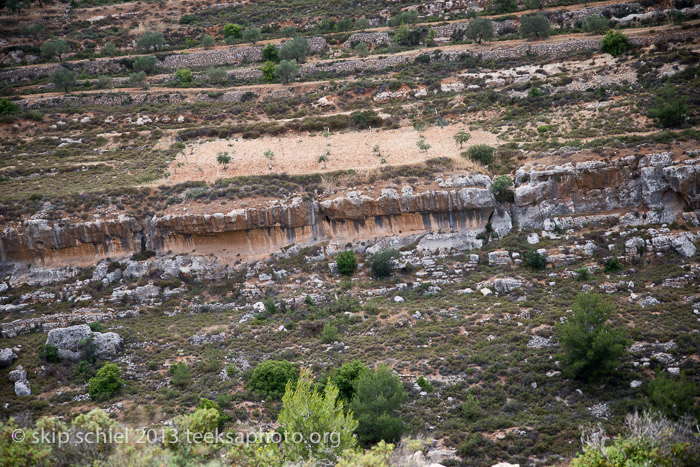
<box><xmin>648</xmin><ymin>372</ymin><xmax>698</xmax><ymax>420</ymax></box>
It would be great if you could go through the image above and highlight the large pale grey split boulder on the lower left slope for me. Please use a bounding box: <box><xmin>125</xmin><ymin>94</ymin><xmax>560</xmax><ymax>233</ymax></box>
<box><xmin>46</xmin><ymin>324</ymin><xmax>123</xmax><ymax>361</ymax></box>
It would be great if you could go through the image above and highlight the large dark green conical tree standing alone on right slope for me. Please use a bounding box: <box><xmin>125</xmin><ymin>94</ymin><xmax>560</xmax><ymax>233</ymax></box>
<box><xmin>557</xmin><ymin>293</ymin><xmax>629</xmax><ymax>380</ymax></box>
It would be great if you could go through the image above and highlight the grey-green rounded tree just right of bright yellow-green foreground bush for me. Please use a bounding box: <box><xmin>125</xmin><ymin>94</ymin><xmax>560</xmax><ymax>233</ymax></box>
<box><xmin>350</xmin><ymin>365</ymin><xmax>408</xmax><ymax>446</ymax></box>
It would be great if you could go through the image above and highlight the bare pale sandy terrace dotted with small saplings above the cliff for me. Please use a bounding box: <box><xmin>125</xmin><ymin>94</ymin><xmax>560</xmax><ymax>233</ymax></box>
<box><xmin>160</xmin><ymin>125</ymin><xmax>498</xmax><ymax>185</ymax></box>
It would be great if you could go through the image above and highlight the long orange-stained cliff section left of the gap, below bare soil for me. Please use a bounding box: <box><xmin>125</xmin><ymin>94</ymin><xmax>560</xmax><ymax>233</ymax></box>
<box><xmin>0</xmin><ymin>185</ymin><xmax>497</xmax><ymax>265</ymax></box>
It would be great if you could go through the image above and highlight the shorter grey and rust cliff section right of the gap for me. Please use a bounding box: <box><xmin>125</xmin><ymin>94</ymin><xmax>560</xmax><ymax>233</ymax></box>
<box><xmin>513</xmin><ymin>153</ymin><xmax>700</xmax><ymax>228</ymax></box>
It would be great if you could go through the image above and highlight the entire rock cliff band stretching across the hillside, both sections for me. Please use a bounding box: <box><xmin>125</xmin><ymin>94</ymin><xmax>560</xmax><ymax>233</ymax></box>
<box><xmin>0</xmin><ymin>154</ymin><xmax>700</xmax><ymax>266</ymax></box>
